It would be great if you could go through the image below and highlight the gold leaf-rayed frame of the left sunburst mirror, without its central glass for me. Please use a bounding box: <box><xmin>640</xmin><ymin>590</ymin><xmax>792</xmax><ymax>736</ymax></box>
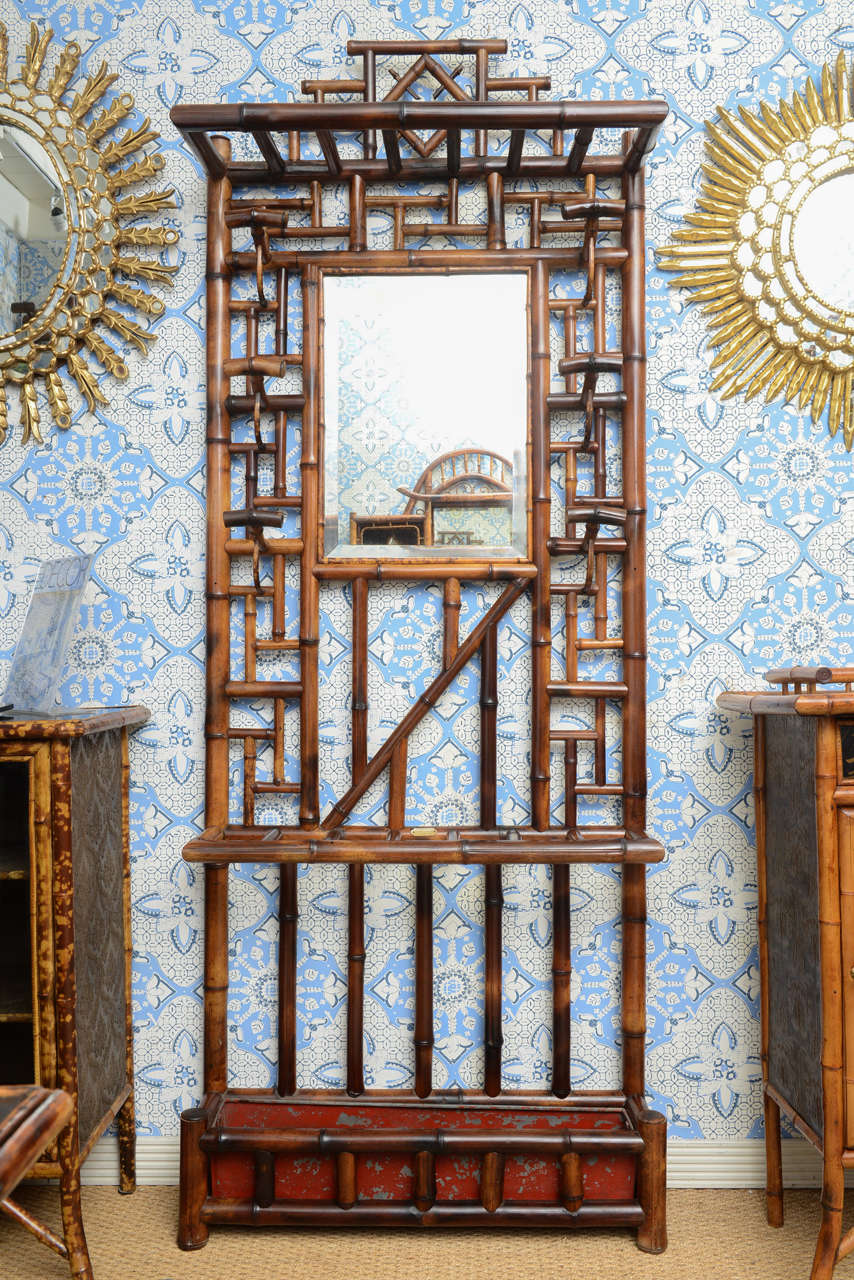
<box><xmin>0</xmin><ymin>23</ymin><xmax>178</xmax><ymax>444</ymax></box>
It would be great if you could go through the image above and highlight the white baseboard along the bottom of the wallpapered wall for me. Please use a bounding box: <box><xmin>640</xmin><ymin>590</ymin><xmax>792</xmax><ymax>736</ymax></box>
<box><xmin>83</xmin><ymin>1137</ymin><xmax>850</xmax><ymax>1187</ymax></box>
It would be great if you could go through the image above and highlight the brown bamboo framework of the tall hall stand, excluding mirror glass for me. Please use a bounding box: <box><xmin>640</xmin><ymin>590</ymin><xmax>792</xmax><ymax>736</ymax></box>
<box><xmin>173</xmin><ymin>41</ymin><xmax>666</xmax><ymax>1252</ymax></box>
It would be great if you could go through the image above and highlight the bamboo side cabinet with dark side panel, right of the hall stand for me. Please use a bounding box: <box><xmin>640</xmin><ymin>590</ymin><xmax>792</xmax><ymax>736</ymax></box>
<box><xmin>717</xmin><ymin>667</ymin><xmax>854</xmax><ymax>1280</ymax></box>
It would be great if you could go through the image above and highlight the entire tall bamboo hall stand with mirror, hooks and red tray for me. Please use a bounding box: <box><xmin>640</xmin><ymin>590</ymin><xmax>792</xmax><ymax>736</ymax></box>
<box><xmin>172</xmin><ymin>40</ymin><xmax>667</xmax><ymax>1252</ymax></box>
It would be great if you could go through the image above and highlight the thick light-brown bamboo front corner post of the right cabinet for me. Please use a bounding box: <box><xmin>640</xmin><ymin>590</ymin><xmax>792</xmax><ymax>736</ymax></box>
<box><xmin>810</xmin><ymin>716</ymin><xmax>845</xmax><ymax>1280</ymax></box>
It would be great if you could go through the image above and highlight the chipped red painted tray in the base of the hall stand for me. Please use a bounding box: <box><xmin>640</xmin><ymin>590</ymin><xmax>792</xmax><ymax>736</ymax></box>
<box><xmin>211</xmin><ymin>1100</ymin><xmax>636</xmax><ymax>1204</ymax></box>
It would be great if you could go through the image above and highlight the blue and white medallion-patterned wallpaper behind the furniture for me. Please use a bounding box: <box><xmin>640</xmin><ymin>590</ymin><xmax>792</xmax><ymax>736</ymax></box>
<box><xmin>0</xmin><ymin>0</ymin><xmax>854</xmax><ymax>1140</ymax></box>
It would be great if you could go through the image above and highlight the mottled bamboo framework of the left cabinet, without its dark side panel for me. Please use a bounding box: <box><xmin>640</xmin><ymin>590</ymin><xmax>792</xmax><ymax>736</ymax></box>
<box><xmin>0</xmin><ymin>707</ymin><xmax>149</xmax><ymax>1280</ymax></box>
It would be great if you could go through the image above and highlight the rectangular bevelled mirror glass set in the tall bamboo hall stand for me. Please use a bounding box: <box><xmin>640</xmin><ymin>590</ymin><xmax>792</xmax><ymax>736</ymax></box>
<box><xmin>323</xmin><ymin>273</ymin><xmax>528</xmax><ymax>559</ymax></box>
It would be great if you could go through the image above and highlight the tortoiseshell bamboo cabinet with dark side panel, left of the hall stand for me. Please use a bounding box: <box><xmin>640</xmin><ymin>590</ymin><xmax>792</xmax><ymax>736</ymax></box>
<box><xmin>0</xmin><ymin>707</ymin><xmax>149</xmax><ymax>1280</ymax></box>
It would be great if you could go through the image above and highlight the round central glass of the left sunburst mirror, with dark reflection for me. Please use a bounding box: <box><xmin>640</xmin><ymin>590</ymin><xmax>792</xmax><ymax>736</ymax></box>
<box><xmin>0</xmin><ymin>123</ymin><xmax>68</xmax><ymax>333</ymax></box>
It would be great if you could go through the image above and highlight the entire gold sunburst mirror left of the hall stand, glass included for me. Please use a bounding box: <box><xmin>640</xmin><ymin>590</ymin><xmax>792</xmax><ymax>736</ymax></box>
<box><xmin>0</xmin><ymin>23</ymin><xmax>178</xmax><ymax>443</ymax></box>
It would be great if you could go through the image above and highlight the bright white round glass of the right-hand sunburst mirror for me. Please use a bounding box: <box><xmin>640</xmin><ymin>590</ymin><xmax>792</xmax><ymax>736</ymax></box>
<box><xmin>793</xmin><ymin>173</ymin><xmax>854</xmax><ymax>311</ymax></box>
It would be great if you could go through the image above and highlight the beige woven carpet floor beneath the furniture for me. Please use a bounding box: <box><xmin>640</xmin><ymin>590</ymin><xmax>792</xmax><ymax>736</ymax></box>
<box><xmin>0</xmin><ymin>1187</ymin><xmax>854</xmax><ymax>1280</ymax></box>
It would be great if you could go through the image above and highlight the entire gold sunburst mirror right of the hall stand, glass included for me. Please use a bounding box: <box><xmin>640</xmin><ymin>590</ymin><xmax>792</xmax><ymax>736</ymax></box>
<box><xmin>658</xmin><ymin>54</ymin><xmax>854</xmax><ymax>449</ymax></box>
